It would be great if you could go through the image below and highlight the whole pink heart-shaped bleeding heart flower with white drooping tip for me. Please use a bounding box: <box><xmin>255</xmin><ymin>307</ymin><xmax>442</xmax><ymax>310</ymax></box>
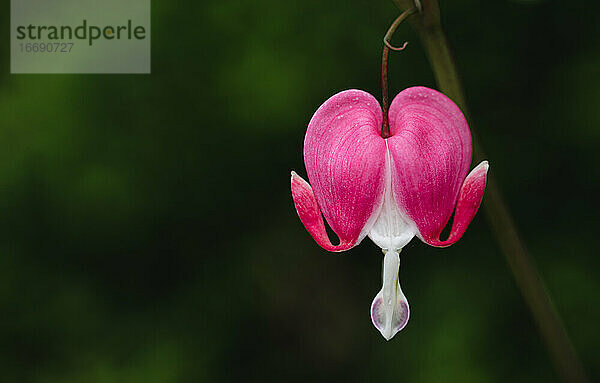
<box><xmin>292</xmin><ymin>87</ymin><xmax>488</xmax><ymax>340</ymax></box>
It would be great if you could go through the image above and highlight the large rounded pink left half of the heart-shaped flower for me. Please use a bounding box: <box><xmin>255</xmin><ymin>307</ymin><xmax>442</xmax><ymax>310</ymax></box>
<box><xmin>304</xmin><ymin>90</ymin><xmax>386</xmax><ymax>246</ymax></box>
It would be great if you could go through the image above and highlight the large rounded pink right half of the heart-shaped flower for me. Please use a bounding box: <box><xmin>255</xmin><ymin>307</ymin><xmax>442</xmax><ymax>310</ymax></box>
<box><xmin>388</xmin><ymin>87</ymin><xmax>476</xmax><ymax>244</ymax></box>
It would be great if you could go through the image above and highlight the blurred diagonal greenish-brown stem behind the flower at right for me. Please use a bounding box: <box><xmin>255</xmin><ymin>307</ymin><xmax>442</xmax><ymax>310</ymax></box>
<box><xmin>393</xmin><ymin>0</ymin><xmax>589</xmax><ymax>382</ymax></box>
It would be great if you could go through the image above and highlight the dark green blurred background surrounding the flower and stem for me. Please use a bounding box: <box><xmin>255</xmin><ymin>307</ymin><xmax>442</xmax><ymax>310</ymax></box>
<box><xmin>0</xmin><ymin>0</ymin><xmax>600</xmax><ymax>383</ymax></box>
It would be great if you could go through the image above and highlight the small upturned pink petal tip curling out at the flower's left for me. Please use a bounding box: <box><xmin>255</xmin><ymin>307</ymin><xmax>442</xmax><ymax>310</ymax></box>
<box><xmin>292</xmin><ymin>172</ymin><xmax>355</xmax><ymax>251</ymax></box>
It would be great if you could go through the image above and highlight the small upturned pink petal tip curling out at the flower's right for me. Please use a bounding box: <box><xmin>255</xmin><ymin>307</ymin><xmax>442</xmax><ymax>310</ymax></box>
<box><xmin>422</xmin><ymin>161</ymin><xmax>489</xmax><ymax>247</ymax></box>
